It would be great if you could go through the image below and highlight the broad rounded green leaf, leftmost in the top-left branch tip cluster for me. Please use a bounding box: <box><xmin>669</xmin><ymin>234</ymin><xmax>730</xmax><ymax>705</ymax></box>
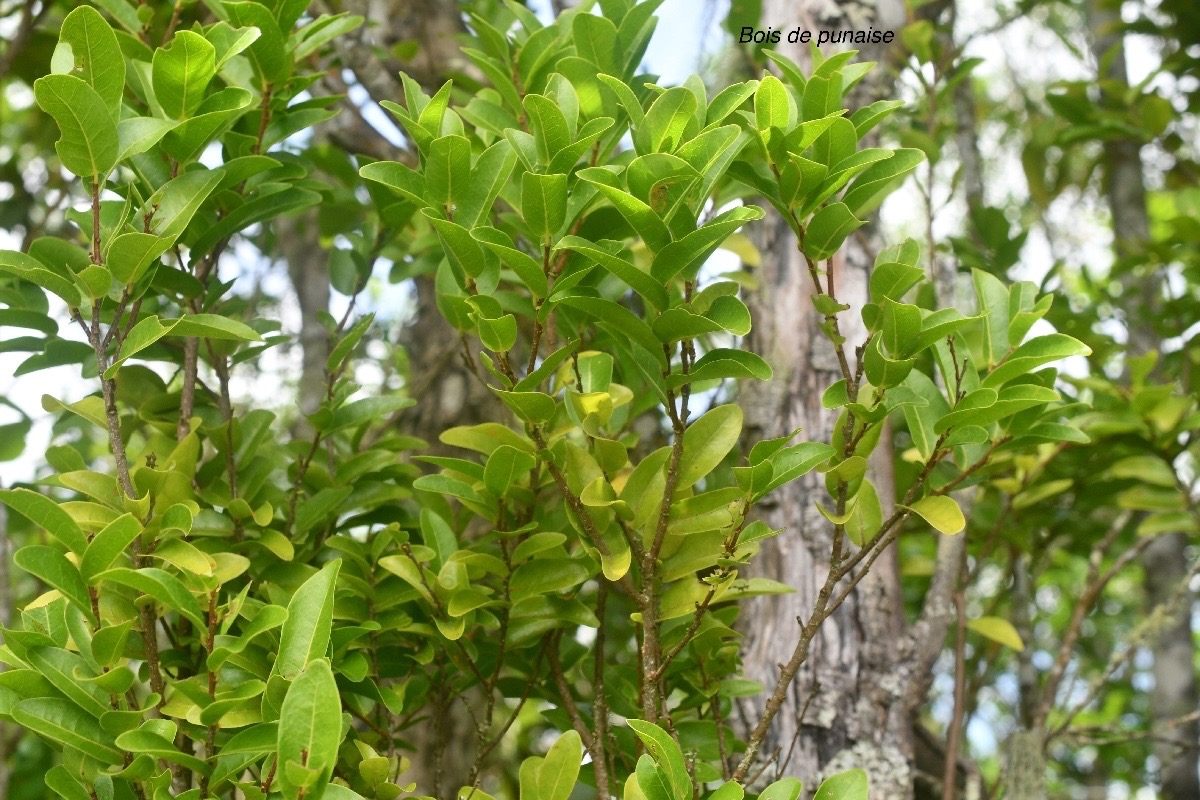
<box><xmin>34</xmin><ymin>76</ymin><xmax>120</xmax><ymax>180</ymax></box>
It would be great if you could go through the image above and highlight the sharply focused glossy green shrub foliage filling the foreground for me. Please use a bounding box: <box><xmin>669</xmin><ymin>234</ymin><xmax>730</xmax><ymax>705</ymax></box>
<box><xmin>0</xmin><ymin>0</ymin><xmax>1086</xmax><ymax>800</ymax></box>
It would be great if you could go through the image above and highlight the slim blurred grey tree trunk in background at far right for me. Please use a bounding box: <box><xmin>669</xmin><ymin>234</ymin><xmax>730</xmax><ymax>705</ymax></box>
<box><xmin>1088</xmin><ymin>0</ymin><xmax>1200</xmax><ymax>800</ymax></box>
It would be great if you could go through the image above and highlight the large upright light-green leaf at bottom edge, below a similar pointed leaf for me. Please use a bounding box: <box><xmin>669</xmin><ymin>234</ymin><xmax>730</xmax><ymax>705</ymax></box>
<box><xmin>277</xmin><ymin>658</ymin><xmax>342</xmax><ymax>800</ymax></box>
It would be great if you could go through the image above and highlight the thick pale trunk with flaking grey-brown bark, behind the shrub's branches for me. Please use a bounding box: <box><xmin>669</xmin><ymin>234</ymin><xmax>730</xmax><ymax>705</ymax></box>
<box><xmin>739</xmin><ymin>0</ymin><xmax>912</xmax><ymax>800</ymax></box>
